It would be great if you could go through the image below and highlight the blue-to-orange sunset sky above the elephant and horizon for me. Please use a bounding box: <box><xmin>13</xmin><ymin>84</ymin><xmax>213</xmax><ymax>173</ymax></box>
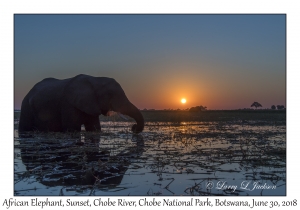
<box><xmin>14</xmin><ymin>14</ymin><xmax>286</xmax><ymax>109</ymax></box>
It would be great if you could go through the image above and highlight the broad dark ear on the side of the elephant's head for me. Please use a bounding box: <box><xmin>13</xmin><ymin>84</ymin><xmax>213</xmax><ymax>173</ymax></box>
<box><xmin>65</xmin><ymin>78</ymin><xmax>101</xmax><ymax>115</ymax></box>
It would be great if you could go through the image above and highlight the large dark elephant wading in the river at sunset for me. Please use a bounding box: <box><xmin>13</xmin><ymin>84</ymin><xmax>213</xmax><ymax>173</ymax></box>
<box><xmin>19</xmin><ymin>74</ymin><xmax>144</xmax><ymax>133</ymax></box>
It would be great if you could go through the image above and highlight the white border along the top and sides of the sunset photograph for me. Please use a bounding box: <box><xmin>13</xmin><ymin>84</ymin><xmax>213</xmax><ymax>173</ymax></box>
<box><xmin>0</xmin><ymin>0</ymin><xmax>300</xmax><ymax>209</ymax></box>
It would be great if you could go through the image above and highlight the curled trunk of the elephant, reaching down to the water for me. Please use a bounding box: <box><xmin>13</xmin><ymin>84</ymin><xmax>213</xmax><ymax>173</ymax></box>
<box><xmin>120</xmin><ymin>102</ymin><xmax>144</xmax><ymax>133</ymax></box>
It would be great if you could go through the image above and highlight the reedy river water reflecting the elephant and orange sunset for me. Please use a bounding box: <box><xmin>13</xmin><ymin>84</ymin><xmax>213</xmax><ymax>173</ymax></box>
<box><xmin>14</xmin><ymin>121</ymin><xmax>286</xmax><ymax>196</ymax></box>
